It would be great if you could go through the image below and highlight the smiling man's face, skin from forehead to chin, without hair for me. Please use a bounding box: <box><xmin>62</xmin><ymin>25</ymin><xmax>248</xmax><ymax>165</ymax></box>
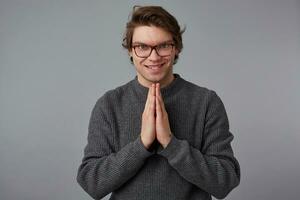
<box><xmin>129</xmin><ymin>26</ymin><xmax>178</xmax><ymax>87</ymax></box>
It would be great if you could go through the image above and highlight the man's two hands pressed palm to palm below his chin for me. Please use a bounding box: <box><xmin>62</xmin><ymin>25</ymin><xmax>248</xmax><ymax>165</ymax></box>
<box><xmin>141</xmin><ymin>83</ymin><xmax>171</xmax><ymax>149</ymax></box>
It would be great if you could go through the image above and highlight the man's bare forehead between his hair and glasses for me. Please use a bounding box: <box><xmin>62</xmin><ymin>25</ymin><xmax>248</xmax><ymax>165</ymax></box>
<box><xmin>132</xmin><ymin>26</ymin><xmax>172</xmax><ymax>45</ymax></box>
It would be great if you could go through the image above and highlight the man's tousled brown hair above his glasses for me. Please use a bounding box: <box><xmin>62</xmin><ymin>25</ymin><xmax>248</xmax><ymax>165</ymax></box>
<box><xmin>122</xmin><ymin>6</ymin><xmax>184</xmax><ymax>64</ymax></box>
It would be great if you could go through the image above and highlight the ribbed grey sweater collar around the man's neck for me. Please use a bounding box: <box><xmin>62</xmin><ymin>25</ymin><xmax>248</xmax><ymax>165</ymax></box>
<box><xmin>133</xmin><ymin>74</ymin><xmax>183</xmax><ymax>97</ymax></box>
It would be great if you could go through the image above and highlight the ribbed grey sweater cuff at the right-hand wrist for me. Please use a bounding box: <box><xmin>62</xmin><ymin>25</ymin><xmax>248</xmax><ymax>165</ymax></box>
<box><xmin>157</xmin><ymin>135</ymin><xmax>182</xmax><ymax>160</ymax></box>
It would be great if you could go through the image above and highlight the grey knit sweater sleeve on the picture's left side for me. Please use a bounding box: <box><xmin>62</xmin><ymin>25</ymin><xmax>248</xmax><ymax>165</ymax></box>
<box><xmin>77</xmin><ymin>96</ymin><xmax>152</xmax><ymax>199</ymax></box>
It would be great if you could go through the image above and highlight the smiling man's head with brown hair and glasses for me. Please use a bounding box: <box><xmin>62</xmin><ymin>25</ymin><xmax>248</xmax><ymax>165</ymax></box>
<box><xmin>122</xmin><ymin>6</ymin><xmax>183</xmax><ymax>85</ymax></box>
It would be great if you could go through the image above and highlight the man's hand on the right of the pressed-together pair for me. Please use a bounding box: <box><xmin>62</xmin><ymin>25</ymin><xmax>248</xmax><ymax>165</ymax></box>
<box><xmin>155</xmin><ymin>83</ymin><xmax>172</xmax><ymax>148</ymax></box>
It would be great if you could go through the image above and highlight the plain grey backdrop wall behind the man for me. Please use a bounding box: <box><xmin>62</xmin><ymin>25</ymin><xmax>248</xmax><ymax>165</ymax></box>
<box><xmin>0</xmin><ymin>0</ymin><xmax>300</xmax><ymax>200</ymax></box>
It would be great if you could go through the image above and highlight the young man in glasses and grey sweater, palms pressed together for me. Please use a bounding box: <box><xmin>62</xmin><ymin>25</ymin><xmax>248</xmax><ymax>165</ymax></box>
<box><xmin>77</xmin><ymin>6</ymin><xmax>240</xmax><ymax>200</ymax></box>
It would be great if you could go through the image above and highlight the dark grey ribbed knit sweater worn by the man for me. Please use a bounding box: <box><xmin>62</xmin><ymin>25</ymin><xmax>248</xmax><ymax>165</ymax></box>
<box><xmin>77</xmin><ymin>74</ymin><xmax>240</xmax><ymax>200</ymax></box>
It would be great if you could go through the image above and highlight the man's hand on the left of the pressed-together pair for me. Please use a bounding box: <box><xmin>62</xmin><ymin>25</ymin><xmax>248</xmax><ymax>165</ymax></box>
<box><xmin>141</xmin><ymin>84</ymin><xmax>155</xmax><ymax>149</ymax></box>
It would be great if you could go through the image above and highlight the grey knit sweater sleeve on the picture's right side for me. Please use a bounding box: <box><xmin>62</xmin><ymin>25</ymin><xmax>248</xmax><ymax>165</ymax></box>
<box><xmin>158</xmin><ymin>91</ymin><xmax>240</xmax><ymax>199</ymax></box>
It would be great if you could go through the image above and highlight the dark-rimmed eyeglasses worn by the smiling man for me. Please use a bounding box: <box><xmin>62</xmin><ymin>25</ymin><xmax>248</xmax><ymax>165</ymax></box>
<box><xmin>132</xmin><ymin>43</ymin><xmax>175</xmax><ymax>58</ymax></box>
